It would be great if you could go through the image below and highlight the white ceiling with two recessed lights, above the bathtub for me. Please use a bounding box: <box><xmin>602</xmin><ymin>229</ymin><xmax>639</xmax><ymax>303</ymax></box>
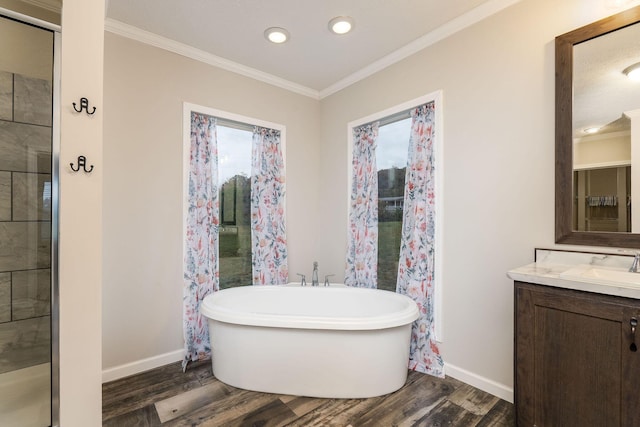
<box><xmin>107</xmin><ymin>0</ymin><xmax>519</xmax><ymax>96</ymax></box>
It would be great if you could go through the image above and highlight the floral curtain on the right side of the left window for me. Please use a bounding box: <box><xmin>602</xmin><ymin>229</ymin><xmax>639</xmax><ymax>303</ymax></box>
<box><xmin>251</xmin><ymin>126</ymin><xmax>289</xmax><ymax>285</ymax></box>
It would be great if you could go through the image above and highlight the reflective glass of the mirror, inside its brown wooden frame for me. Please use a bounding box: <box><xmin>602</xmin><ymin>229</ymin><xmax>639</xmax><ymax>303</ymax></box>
<box><xmin>572</xmin><ymin>23</ymin><xmax>640</xmax><ymax>233</ymax></box>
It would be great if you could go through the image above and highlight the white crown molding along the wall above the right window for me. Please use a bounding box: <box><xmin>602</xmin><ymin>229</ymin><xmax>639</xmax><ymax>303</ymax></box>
<box><xmin>320</xmin><ymin>0</ymin><xmax>520</xmax><ymax>99</ymax></box>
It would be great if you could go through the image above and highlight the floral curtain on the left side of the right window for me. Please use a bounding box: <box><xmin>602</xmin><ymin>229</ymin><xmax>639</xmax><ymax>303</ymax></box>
<box><xmin>344</xmin><ymin>122</ymin><xmax>378</xmax><ymax>288</ymax></box>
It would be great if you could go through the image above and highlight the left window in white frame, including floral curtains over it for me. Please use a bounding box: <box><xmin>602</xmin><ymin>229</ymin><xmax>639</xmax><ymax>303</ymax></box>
<box><xmin>183</xmin><ymin>103</ymin><xmax>288</xmax><ymax>289</ymax></box>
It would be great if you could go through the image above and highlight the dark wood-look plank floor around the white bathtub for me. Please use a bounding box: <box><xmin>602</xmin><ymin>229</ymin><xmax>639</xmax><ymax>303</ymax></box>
<box><xmin>102</xmin><ymin>362</ymin><xmax>515</xmax><ymax>427</ymax></box>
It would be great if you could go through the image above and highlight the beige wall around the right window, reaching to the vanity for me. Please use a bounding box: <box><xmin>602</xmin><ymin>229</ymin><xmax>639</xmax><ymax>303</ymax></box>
<box><xmin>317</xmin><ymin>0</ymin><xmax>636</xmax><ymax>397</ymax></box>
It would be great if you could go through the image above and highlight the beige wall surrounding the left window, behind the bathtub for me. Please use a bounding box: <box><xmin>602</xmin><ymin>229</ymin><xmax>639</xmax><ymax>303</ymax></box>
<box><xmin>102</xmin><ymin>32</ymin><xmax>322</xmax><ymax>370</ymax></box>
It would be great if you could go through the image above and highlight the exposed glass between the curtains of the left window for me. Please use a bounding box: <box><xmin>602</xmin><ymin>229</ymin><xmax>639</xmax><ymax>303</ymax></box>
<box><xmin>217</xmin><ymin>124</ymin><xmax>253</xmax><ymax>289</ymax></box>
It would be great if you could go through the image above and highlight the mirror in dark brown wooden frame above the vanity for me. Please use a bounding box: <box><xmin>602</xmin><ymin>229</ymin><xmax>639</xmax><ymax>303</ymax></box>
<box><xmin>555</xmin><ymin>6</ymin><xmax>640</xmax><ymax>248</ymax></box>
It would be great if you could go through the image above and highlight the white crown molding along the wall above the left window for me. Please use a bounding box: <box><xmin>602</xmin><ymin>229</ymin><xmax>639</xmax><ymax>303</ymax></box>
<box><xmin>105</xmin><ymin>18</ymin><xmax>320</xmax><ymax>99</ymax></box>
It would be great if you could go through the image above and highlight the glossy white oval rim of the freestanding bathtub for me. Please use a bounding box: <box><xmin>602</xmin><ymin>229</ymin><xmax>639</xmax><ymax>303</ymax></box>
<box><xmin>200</xmin><ymin>285</ymin><xmax>419</xmax><ymax>331</ymax></box>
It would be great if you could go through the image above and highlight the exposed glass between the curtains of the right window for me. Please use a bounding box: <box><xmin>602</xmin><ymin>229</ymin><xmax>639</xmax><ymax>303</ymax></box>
<box><xmin>376</xmin><ymin>118</ymin><xmax>411</xmax><ymax>292</ymax></box>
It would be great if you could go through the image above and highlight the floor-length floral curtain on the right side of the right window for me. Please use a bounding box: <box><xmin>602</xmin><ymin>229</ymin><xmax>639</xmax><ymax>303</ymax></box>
<box><xmin>397</xmin><ymin>102</ymin><xmax>444</xmax><ymax>377</ymax></box>
